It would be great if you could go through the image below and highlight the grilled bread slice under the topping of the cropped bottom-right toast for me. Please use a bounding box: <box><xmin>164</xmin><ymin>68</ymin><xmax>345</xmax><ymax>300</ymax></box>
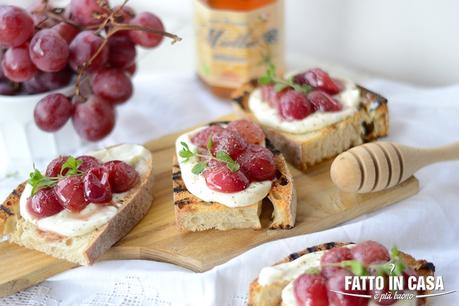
<box><xmin>248</xmin><ymin>242</ymin><xmax>435</xmax><ymax>306</ymax></box>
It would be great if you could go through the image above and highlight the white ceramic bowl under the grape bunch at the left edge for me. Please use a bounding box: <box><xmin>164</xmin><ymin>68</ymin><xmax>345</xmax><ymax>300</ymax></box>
<box><xmin>0</xmin><ymin>85</ymin><xmax>83</xmax><ymax>173</ymax></box>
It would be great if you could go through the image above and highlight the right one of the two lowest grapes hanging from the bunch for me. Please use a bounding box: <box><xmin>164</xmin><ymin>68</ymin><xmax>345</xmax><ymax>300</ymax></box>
<box><xmin>72</xmin><ymin>95</ymin><xmax>115</xmax><ymax>141</ymax></box>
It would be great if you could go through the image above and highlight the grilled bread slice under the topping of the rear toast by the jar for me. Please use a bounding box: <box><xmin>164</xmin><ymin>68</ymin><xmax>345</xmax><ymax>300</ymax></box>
<box><xmin>233</xmin><ymin>82</ymin><xmax>389</xmax><ymax>171</ymax></box>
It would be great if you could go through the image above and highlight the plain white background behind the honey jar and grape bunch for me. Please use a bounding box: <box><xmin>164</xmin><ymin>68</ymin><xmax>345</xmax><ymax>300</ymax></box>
<box><xmin>6</xmin><ymin>0</ymin><xmax>459</xmax><ymax>86</ymax></box>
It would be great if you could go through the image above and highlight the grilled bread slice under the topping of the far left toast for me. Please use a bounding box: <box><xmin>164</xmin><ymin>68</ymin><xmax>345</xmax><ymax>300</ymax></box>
<box><xmin>0</xmin><ymin>144</ymin><xmax>153</xmax><ymax>265</ymax></box>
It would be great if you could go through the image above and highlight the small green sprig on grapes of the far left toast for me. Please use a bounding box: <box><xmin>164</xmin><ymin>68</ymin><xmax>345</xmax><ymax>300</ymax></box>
<box><xmin>28</xmin><ymin>156</ymin><xmax>83</xmax><ymax>196</ymax></box>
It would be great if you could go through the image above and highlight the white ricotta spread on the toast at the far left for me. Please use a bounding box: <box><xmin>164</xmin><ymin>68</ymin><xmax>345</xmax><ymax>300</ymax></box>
<box><xmin>19</xmin><ymin>144</ymin><xmax>152</xmax><ymax>237</ymax></box>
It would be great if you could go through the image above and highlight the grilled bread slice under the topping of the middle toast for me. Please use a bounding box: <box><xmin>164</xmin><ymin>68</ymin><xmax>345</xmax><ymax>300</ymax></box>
<box><xmin>172</xmin><ymin>137</ymin><xmax>297</xmax><ymax>232</ymax></box>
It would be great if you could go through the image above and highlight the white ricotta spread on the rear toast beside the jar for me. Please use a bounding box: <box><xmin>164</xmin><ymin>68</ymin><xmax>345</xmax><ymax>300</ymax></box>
<box><xmin>249</xmin><ymin>80</ymin><xmax>360</xmax><ymax>134</ymax></box>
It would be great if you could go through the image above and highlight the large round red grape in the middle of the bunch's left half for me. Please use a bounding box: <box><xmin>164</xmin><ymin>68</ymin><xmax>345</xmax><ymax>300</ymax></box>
<box><xmin>29</xmin><ymin>29</ymin><xmax>69</xmax><ymax>72</ymax></box>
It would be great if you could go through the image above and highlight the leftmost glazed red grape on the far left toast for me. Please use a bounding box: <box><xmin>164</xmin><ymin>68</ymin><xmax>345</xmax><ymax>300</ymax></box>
<box><xmin>27</xmin><ymin>188</ymin><xmax>64</xmax><ymax>218</ymax></box>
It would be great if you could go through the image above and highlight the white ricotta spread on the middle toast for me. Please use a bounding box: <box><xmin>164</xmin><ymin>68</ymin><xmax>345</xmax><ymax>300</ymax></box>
<box><xmin>176</xmin><ymin>127</ymin><xmax>272</xmax><ymax>207</ymax></box>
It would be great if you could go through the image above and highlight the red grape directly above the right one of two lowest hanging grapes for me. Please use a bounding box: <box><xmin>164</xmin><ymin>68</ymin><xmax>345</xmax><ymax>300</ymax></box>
<box><xmin>91</xmin><ymin>68</ymin><xmax>132</xmax><ymax>104</ymax></box>
